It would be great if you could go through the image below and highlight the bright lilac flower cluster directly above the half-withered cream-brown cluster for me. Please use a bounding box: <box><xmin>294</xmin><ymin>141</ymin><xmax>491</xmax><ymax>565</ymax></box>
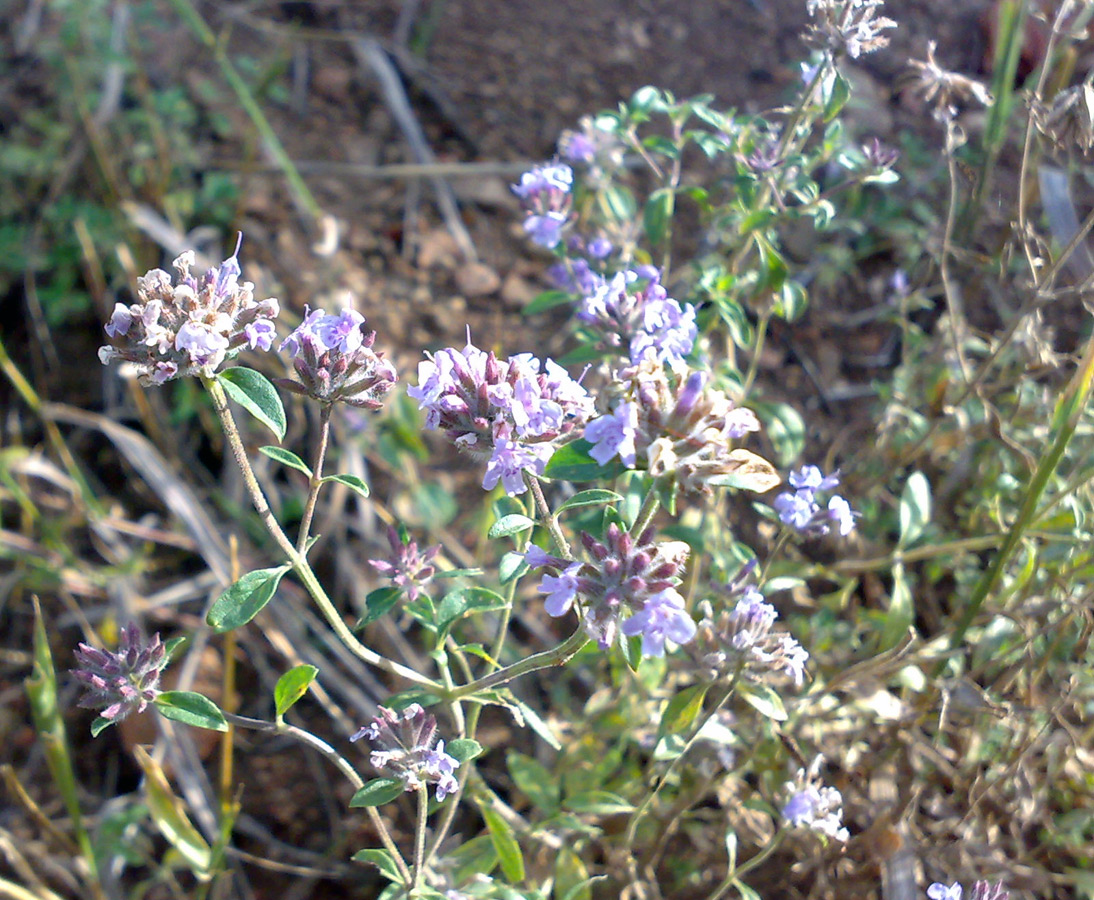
<box><xmin>574</xmin><ymin>266</ymin><xmax>699</xmax><ymax>365</ymax></box>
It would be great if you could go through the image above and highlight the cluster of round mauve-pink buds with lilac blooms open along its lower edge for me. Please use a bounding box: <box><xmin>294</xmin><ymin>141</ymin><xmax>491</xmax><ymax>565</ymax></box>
<box><xmin>525</xmin><ymin>523</ymin><xmax>695</xmax><ymax>656</ymax></box>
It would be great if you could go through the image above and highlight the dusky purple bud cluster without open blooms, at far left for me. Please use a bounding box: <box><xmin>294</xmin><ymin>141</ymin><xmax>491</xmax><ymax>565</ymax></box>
<box><xmin>72</xmin><ymin>623</ymin><xmax>167</xmax><ymax>722</ymax></box>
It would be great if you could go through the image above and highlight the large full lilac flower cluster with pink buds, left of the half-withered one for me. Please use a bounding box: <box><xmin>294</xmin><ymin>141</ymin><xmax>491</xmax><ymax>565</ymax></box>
<box><xmin>407</xmin><ymin>342</ymin><xmax>593</xmax><ymax>494</ymax></box>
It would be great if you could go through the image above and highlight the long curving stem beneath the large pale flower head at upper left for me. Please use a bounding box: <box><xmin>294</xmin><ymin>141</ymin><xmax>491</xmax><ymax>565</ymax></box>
<box><xmin>201</xmin><ymin>375</ymin><xmax>443</xmax><ymax>693</ymax></box>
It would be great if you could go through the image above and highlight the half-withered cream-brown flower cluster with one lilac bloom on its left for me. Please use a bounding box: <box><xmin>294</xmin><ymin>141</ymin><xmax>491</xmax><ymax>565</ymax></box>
<box><xmin>585</xmin><ymin>358</ymin><xmax>779</xmax><ymax>493</ymax></box>
